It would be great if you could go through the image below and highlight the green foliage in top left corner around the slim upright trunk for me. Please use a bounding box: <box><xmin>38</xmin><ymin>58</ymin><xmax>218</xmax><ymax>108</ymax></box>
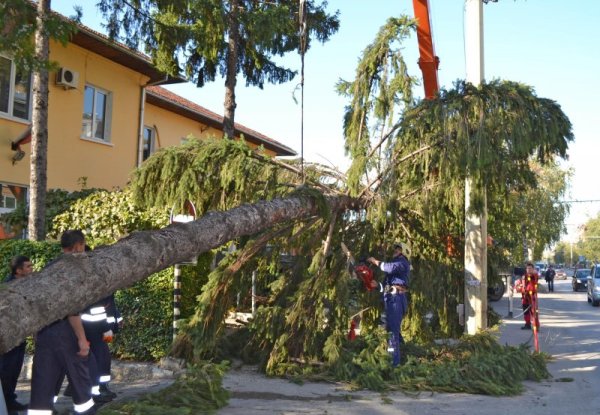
<box><xmin>0</xmin><ymin>0</ymin><xmax>81</xmax><ymax>71</ymax></box>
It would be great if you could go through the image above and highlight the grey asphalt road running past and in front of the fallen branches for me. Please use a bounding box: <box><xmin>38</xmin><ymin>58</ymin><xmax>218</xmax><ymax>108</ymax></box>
<box><xmin>218</xmin><ymin>280</ymin><xmax>600</xmax><ymax>415</ymax></box>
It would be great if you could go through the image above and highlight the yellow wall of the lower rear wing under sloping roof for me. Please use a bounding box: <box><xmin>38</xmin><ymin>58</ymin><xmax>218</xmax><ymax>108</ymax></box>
<box><xmin>144</xmin><ymin>103</ymin><xmax>276</xmax><ymax>157</ymax></box>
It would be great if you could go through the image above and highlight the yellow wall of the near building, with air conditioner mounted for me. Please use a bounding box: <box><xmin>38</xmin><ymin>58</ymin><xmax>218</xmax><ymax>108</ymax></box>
<box><xmin>0</xmin><ymin>38</ymin><xmax>148</xmax><ymax>190</ymax></box>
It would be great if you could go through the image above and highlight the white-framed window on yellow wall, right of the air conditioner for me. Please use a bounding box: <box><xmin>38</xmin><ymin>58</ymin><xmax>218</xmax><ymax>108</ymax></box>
<box><xmin>81</xmin><ymin>85</ymin><xmax>111</xmax><ymax>141</ymax></box>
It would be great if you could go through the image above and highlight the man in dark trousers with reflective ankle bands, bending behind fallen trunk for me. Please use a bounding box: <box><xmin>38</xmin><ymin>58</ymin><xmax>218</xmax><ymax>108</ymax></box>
<box><xmin>27</xmin><ymin>230</ymin><xmax>96</xmax><ymax>415</ymax></box>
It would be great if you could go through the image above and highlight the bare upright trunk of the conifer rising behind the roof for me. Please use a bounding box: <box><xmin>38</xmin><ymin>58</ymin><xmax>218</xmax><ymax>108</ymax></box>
<box><xmin>223</xmin><ymin>0</ymin><xmax>240</xmax><ymax>139</ymax></box>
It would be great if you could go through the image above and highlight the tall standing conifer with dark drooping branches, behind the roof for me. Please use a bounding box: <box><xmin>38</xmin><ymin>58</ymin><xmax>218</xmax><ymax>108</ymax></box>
<box><xmin>98</xmin><ymin>0</ymin><xmax>339</xmax><ymax>138</ymax></box>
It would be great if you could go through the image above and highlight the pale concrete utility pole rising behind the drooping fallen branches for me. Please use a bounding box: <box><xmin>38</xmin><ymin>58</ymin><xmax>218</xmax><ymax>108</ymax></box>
<box><xmin>465</xmin><ymin>0</ymin><xmax>487</xmax><ymax>334</ymax></box>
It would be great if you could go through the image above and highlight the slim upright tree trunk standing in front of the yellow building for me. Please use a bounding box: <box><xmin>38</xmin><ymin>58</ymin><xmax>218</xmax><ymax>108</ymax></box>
<box><xmin>28</xmin><ymin>0</ymin><xmax>50</xmax><ymax>241</ymax></box>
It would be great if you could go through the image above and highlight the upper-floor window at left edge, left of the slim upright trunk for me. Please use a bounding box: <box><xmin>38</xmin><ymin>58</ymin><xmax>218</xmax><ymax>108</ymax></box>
<box><xmin>0</xmin><ymin>56</ymin><xmax>31</xmax><ymax>120</ymax></box>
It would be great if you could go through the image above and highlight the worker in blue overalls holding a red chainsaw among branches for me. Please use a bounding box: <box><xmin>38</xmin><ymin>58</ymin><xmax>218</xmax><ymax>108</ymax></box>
<box><xmin>367</xmin><ymin>243</ymin><xmax>410</xmax><ymax>367</ymax></box>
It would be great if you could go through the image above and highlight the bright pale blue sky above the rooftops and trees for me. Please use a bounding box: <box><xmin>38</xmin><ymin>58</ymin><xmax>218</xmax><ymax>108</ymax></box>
<box><xmin>52</xmin><ymin>0</ymin><xmax>600</xmax><ymax>240</ymax></box>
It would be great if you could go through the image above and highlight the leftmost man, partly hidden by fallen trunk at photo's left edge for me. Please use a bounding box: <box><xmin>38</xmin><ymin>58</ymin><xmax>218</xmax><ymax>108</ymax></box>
<box><xmin>0</xmin><ymin>255</ymin><xmax>33</xmax><ymax>412</ymax></box>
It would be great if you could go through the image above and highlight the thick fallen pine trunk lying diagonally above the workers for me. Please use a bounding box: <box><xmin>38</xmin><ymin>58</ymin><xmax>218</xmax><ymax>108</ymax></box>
<box><xmin>0</xmin><ymin>196</ymin><xmax>360</xmax><ymax>353</ymax></box>
